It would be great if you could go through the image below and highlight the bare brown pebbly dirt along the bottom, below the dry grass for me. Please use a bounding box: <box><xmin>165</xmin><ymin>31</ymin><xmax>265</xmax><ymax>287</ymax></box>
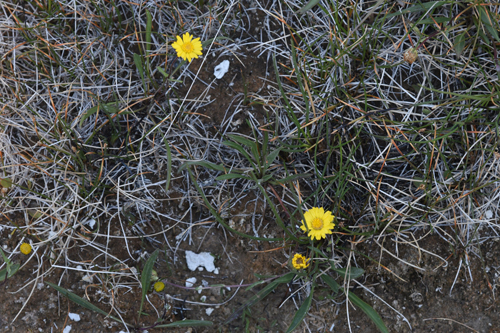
<box><xmin>0</xmin><ymin>214</ymin><xmax>500</xmax><ymax>332</ymax></box>
